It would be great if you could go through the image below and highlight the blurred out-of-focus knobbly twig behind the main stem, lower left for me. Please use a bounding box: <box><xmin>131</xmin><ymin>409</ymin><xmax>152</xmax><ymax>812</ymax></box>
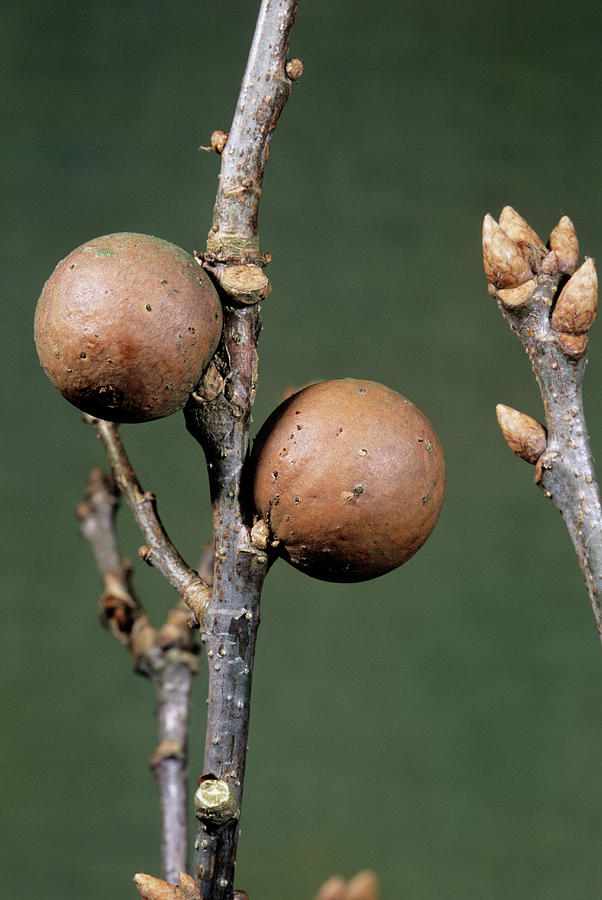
<box><xmin>77</xmin><ymin>469</ymin><xmax>198</xmax><ymax>881</ymax></box>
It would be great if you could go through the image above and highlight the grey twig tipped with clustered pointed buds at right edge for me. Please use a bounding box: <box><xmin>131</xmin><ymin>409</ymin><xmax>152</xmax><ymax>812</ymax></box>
<box><xmin>483</xmin><ymin>207</ymin><xmax>602</xmax><ymax>640</ymax></box>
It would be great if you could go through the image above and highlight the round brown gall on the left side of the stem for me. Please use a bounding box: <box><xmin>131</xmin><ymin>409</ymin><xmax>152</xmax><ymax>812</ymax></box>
<box><xmin>34</xmin><ymin>233</ymin><xmax>222</xmax><ymax>422</ymax></box>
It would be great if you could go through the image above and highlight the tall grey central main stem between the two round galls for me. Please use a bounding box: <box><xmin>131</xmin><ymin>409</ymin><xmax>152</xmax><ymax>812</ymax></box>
<box><xmin>185</xmin><ymin>0</ymin><xmax>300</xmax><ymax>900</ymax></box>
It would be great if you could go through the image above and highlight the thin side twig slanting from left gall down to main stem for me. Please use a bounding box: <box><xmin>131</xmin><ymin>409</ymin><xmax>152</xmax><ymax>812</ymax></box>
<box><xmin>84</xmin><ymin>416</ymin><xmax>211</xmax><ymax>621</ymax></box>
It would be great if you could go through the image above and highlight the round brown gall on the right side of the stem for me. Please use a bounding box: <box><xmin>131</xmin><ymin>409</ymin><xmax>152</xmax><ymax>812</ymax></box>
<box><xmin>252</xmin><ymin>378</ymin><xmax>445</xmax><ymax>582</ymax></box>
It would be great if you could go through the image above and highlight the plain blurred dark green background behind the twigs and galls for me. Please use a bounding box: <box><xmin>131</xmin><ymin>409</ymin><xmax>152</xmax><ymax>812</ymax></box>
<box><xmin>0</xmin><ymin>0</ymin><xmax>602</xmax><ymax>900</ymax></box>
